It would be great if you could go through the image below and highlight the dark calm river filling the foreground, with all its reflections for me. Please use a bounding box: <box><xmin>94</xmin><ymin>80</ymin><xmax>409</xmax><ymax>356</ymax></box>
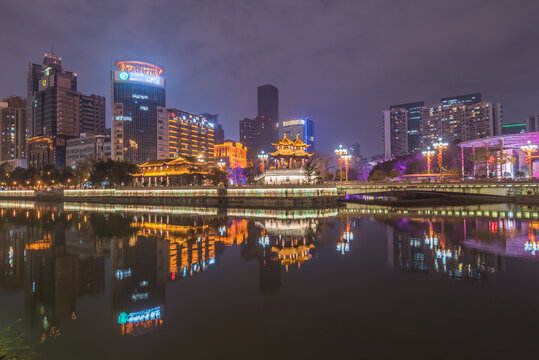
<box><xmin>0</xmin><ymin>202</ymin><xmax>539</xmax><ymax>359</ymax></box>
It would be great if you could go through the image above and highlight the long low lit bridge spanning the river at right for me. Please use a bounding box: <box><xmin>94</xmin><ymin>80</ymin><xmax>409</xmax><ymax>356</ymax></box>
<box><xmin>337</xmin><ymin>182</ymin><xmax>539</xmax><ymax>200</ymax></box>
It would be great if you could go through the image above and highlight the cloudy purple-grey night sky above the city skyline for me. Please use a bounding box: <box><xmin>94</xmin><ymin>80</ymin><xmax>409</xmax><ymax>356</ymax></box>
<box><xmin>0</xmin><ymin>0</ymin><xmax>539</xmax><ymax>156</ymax></box>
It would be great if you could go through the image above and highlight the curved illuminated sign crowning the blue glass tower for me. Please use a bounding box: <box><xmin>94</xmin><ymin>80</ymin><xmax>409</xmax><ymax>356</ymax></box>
<box><xmin>114</xmin><ymin>61</ymin><xmax>165</xmax><ymax>87</ymax></box>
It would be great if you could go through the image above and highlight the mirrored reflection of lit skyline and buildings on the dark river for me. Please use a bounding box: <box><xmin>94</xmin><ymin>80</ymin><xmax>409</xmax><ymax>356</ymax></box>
<box><xmin>0</xmin><ymin>202</ymin><xmax>539</xmax><ymax>356</ymax></box>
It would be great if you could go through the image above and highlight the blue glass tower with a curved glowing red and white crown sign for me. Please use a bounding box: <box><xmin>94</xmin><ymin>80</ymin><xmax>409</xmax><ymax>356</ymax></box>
<box><xmin>111</xmin><ymin>61</ymin><xmax>168</xmax><ymax>164</ymax></box>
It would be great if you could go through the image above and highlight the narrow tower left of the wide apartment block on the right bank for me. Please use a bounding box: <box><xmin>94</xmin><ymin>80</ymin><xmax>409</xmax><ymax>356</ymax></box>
<box><xmin>382</xmin><ymin>108</ymin><xmax>408</xmax><ymax>159</ymax></box>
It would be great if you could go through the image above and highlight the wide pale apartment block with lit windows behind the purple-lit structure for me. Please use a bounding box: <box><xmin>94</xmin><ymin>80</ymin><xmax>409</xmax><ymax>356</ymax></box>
<box><xmin>420</xmin><ymin>102</ymin><xmax>503</xmax><ymax>149</ymax></box>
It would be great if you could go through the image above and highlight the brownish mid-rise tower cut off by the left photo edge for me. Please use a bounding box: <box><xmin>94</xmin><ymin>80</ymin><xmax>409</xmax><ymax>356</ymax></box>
<box><xmin>0</xmin><ymin>96</ymin><xmax>26</xmax><ymax>161</ymax></box>
